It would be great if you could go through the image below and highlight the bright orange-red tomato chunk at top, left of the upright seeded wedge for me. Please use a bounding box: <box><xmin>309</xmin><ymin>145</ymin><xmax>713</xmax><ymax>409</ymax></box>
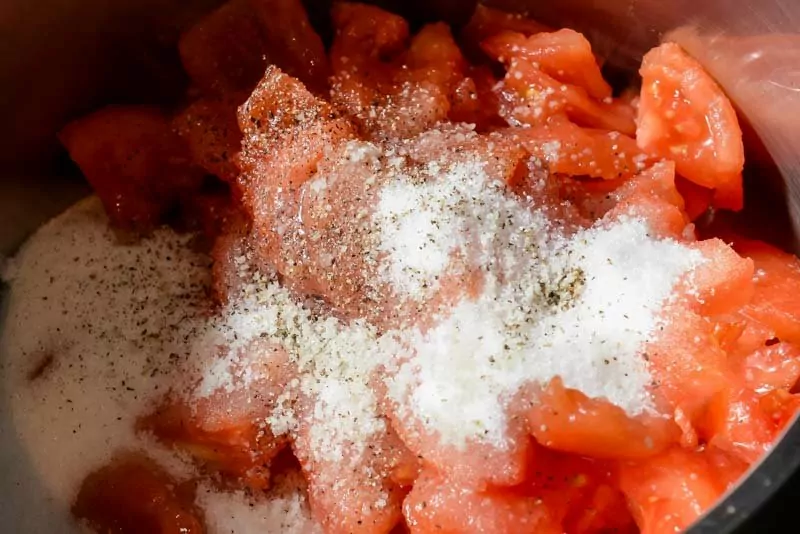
<box><xmin>481</xmin><ymin>29</ymin><xmax>611</xmax><ymax>100</ymax></box>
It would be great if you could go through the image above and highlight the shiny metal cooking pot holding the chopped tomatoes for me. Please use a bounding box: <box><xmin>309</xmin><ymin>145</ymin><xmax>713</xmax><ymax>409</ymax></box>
<box><xmin>0</xmin><ymin>0</ymin><xmax>800</xmax><ymax>534</ymax></box>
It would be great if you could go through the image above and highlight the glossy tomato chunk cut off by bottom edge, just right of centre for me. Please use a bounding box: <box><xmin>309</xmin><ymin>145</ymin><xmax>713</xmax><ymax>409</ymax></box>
<box><xmin>403</xmin><ymin>469</ymin><xmax>563</xmax><ymax>534</ymax></box>
